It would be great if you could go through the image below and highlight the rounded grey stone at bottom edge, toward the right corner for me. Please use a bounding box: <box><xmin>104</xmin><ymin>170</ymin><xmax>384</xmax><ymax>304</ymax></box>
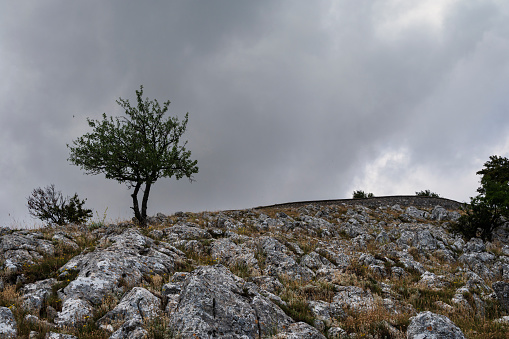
<box><xmin>407</xmin><ymin>311</ymin><xmax>465</xmax><ymax>339</ymax></box>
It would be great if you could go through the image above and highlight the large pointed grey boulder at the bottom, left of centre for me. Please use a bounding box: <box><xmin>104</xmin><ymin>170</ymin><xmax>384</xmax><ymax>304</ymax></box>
<box><xmin>170</xmin><ymin>265</ymin><xmax>293</xmax><ymax>338</ymax></box>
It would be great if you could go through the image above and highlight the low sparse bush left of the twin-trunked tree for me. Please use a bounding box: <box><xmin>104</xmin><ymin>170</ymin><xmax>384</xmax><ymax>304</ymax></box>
<box><xmin>27</xmin><ymin>184</ymin><xmax>92</xmax><ymax>225</ymax></box>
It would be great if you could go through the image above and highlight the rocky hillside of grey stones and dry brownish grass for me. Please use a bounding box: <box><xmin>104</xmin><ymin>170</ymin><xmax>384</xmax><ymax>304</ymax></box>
<box><xmin>0</xmin><ymin>203</ymin><xmax>509</xmax><ymax>338</ymax></box>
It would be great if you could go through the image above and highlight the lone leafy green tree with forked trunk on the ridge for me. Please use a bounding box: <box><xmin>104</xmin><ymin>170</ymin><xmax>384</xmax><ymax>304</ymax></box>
<box><xmin>67</xmin><ymin>86</ymin><xmax>198</xmax><ymax>225</ymax></box>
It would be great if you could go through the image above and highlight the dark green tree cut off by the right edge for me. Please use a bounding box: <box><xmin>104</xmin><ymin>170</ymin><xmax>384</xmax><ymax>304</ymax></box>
<box><xmin>451</xmin><ymin>156</ymin><xmax>509</xmax><ymax>240</ymax></box>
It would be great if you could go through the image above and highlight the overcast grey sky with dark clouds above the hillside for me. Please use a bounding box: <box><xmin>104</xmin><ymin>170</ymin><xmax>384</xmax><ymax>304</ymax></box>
<box><xmin>0</xmin><ymin>0</ymin><xmax>509</xmax><ymax>227</ymax></box>
